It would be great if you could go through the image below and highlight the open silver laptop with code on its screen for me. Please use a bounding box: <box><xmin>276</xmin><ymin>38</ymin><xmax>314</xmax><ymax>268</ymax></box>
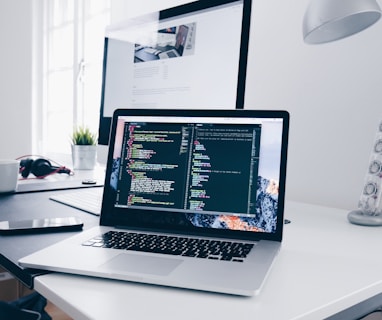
<box><xmin>19</xmin><ymin>109</ymin><xmax>289</xmax><ymax>296</ymax></box>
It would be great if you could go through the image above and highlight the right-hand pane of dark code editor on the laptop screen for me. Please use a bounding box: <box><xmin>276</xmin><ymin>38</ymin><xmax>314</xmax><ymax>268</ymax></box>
<box><xmin>189</xmin><ymin>125</ymin><xmax>260</xmax><ymax>214</ymax></box>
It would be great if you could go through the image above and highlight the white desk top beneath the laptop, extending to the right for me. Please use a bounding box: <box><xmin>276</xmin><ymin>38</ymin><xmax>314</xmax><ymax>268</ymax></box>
<box><xmin>35</xmin><ymin>202</ymin><xmax>382</xmax><ymax>320</ymax></box>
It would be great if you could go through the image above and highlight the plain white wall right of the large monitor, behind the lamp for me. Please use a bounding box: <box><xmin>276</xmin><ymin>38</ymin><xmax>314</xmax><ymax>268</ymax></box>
<box><xmin>245</xmin><ymin>0</ymin><xmax>382</xmax><ymax>209</ymax></box>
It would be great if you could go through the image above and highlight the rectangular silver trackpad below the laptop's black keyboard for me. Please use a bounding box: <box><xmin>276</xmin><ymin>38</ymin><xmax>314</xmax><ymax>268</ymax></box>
<box><xmin>100</xmin><ymin>254</ymin><xmax>183</xmax><ymax>276</ymax></box>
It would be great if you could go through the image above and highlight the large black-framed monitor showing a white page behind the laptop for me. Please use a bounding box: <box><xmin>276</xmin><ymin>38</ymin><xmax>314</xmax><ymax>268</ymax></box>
<box><xmin>99</xmin><ymin>0</ymin><xmax>251</xmax><ymax>145</ymax></box>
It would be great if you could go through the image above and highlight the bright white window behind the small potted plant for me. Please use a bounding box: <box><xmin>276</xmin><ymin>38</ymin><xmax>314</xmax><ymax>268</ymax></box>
<box><xmin>40</xmin><ymin>0</ymin><xmax>111</xmax><ymax>153</ymax></box>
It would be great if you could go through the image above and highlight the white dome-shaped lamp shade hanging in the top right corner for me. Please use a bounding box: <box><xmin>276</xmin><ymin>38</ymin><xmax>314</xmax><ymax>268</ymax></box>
<box><xmin>303</xmin><ymin>0</ymin><xmax>382</xmax><ymax>44</ymax></box>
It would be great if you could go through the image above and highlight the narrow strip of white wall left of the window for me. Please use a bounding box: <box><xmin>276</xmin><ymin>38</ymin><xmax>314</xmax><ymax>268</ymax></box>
<box><xmin>0</xmin><ymin>0</ymin><xmax>32</xmax><ymax>158</ymax></box>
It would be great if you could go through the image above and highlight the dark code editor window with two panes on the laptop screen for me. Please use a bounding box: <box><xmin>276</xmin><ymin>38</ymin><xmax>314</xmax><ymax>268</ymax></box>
<box><xmin>117</xmin><ymin>123</ymin><xmax>261</xmax><ymax>215</ymax></box>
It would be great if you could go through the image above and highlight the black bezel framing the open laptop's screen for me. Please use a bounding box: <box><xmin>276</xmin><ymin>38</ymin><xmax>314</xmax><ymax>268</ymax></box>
<box><xmin>100</xmin><ymin>109</ymin><xmax>289</xmax><ymax>241</ymax></box>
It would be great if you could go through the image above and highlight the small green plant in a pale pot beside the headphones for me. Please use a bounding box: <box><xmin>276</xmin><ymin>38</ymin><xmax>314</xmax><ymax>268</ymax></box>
<box><xmin>71</xmin><ymin>127</ymin><xmax>97</xmax><ymax>170</ymax></box>
